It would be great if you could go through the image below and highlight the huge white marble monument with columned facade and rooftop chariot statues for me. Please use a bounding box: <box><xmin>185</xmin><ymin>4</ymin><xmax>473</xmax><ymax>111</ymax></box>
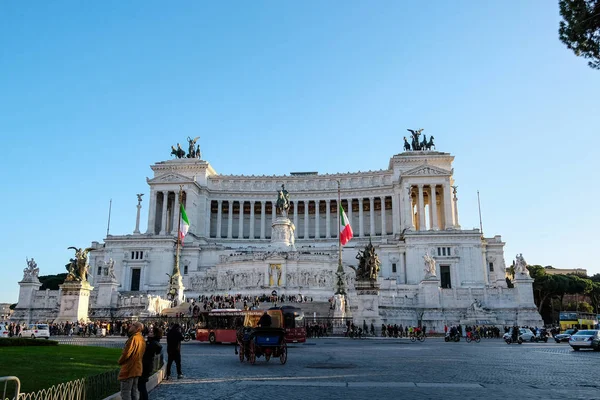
<box><xmin>12</xmin><ymin>129</ymin><xmax>541</xmax><ymax>328</ymax></box>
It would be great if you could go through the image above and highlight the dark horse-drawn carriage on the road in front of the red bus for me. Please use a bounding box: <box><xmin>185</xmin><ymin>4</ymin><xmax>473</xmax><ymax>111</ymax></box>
<box><xmin>236</xmin><ymin>310</ymin><xmax>287</xmax><ymax>364</ymax></box>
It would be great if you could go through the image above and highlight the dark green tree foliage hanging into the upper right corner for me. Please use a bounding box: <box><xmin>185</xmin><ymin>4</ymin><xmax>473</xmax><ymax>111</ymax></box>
<box><xmin>558</xmin><ymin>0</ymin><xmax>600</xmax><ymax>69</ymax></box>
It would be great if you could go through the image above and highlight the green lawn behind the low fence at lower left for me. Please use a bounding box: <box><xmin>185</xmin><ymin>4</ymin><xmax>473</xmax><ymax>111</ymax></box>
<box><xmin>0</xmin><ymin>345</ymin><xmax>121</xmax><ymax>393</ymax></box>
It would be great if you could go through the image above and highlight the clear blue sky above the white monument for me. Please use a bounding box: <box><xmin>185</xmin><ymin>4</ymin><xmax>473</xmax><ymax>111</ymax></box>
<box><xmin>0</xmin><ymin>0</ymin><xmax>600</xmax><ymax>303</ymax></box>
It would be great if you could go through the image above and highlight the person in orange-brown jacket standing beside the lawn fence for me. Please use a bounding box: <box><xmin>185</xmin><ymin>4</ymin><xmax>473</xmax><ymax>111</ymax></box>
<box><xmin>118</xmin><ymin>321</ymin><xmax>146</xmax><ymax>400</ymax></box>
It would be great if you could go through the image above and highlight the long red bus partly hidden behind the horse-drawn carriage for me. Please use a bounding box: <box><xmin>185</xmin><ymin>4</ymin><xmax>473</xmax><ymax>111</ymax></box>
<box><xmin>196</xmin><ymin>306</ymin><xmax>306</xmax><ymax>344</ymax></box>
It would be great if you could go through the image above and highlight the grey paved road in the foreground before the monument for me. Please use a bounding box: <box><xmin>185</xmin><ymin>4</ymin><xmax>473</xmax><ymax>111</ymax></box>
<box><xmin>150</xmin><ymin>338</ymin><xmax>600</xmax><ymax>400</ymax></box>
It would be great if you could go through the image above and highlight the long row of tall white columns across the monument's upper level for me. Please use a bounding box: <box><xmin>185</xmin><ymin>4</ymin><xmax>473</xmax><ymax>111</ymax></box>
<box><xmin>147</xmin><ymin>181</ymin><xmax>459</xmax><ymax>239</ymax></box>
